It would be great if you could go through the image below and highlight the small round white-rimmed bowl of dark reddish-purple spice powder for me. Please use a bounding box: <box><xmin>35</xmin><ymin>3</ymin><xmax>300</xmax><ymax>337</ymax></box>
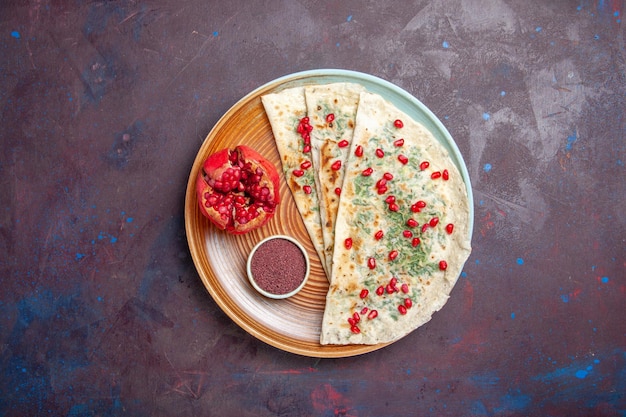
<box><xmin>247</xmin><ymin>235</ymin><xmax>310</xmax><ymax>299</ymax></box>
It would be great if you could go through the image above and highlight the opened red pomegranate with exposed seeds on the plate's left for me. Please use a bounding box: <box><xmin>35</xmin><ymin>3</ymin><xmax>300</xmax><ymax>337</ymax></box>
<box><xmin>196</xmin><ymin>145</ymin><xmax>280</xmax><ymax>234</ymax></box>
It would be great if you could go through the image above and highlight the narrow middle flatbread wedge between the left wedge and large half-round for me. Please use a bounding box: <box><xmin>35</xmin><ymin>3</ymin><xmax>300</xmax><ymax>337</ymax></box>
<box><xmin>304</xmin><ymin>83</ymin><xmax>365</xmax><ymax>281</ymax></box>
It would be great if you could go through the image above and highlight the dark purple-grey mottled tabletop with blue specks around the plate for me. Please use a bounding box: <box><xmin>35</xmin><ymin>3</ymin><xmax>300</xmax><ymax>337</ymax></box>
<box><xmin>0</xmin><ymin>0</ymin><xmax>626</xmax><ymax>417</ymax></box>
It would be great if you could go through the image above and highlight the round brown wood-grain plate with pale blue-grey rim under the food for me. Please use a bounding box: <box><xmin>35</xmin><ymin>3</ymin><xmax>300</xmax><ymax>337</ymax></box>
<box><xmin>185</xmin><ymin>70</ymin><xmax>473</xmax><ymax>358</ymax></box>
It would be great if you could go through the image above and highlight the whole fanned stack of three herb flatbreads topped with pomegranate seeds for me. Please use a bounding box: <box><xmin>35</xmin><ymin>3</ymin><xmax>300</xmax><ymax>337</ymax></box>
<box><xmin>262</xmin><ymin>83</ymin><xmax>471</xmax><ymax>344</ymax></box>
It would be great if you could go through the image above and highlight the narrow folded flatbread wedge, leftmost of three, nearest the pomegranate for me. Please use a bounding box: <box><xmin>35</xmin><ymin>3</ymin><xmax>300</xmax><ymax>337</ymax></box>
<box><xmin>261</xmin><ymin>87</ymin><xmax>330</xmax><ymax>277</ymax></box>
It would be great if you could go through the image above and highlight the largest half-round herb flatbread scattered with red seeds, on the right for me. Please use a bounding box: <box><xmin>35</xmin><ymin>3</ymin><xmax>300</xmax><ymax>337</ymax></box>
<box><xmin>320</xmin><ymin>92</ymin><xmax>471</xmax><ymax>345</ymax></box>
